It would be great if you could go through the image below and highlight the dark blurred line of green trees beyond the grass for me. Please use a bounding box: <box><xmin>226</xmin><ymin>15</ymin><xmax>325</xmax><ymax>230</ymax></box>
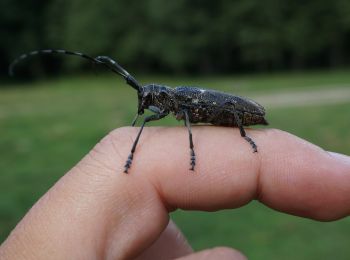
<box><xmin>0</xmin><ymin>0</ymin><xmax>350</xmax><ymax>75</ymax></box>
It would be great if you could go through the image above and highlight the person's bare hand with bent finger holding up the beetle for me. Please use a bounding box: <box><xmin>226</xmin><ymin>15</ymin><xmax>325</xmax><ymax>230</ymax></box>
<box><xmin>0</xmin><ymin>126</ymin><xmax>350</xmax><ymax>259</ymax></box>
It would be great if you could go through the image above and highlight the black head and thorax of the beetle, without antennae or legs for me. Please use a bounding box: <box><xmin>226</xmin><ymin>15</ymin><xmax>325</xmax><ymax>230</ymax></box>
<box><xmin>141</xmin><ymin>84</ymin><xmax>175</xmax><ymax>111</ymax></box>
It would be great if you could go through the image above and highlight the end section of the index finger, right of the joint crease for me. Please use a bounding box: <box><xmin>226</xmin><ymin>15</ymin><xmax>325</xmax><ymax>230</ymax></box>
<box><xmin>258</xmin><ymin>130</ymin><xmax>350</xmax><ymax>221</ymax></box>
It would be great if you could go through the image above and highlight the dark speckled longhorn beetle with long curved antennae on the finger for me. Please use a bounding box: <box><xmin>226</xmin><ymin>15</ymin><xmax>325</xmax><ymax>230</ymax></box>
<box><xmin>9</xmin><ymin>49</ymin><xmax>268</xmax><ymax>173</ymax></box>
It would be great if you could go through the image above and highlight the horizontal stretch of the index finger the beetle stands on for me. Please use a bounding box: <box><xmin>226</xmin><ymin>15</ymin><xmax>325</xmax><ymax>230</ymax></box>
<box><xmin>117</xmin><ymin>126</ymin><xmax>350</xmax><ymax>220</ymax></box>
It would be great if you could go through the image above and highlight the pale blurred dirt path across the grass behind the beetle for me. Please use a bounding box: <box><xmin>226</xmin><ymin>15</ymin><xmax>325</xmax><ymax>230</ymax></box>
<box><xmin>251</xmin><ymin>85</ymin><xmax>350</xmax><ymax>108</ymax></box>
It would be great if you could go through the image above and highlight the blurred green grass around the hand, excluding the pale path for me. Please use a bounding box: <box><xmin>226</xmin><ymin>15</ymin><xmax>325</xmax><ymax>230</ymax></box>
<box><xmin>0</xmin><ymin>70</ymin><xmax>350</xmax><ymax>259</ymax></box>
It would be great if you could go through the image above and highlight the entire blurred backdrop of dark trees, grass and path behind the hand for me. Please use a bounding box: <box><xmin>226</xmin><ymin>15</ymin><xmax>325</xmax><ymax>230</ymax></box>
<box><xmin>0</xmin><ymin>0</ymin><xmax>350</xmax><ymax>259</ymax></box>
